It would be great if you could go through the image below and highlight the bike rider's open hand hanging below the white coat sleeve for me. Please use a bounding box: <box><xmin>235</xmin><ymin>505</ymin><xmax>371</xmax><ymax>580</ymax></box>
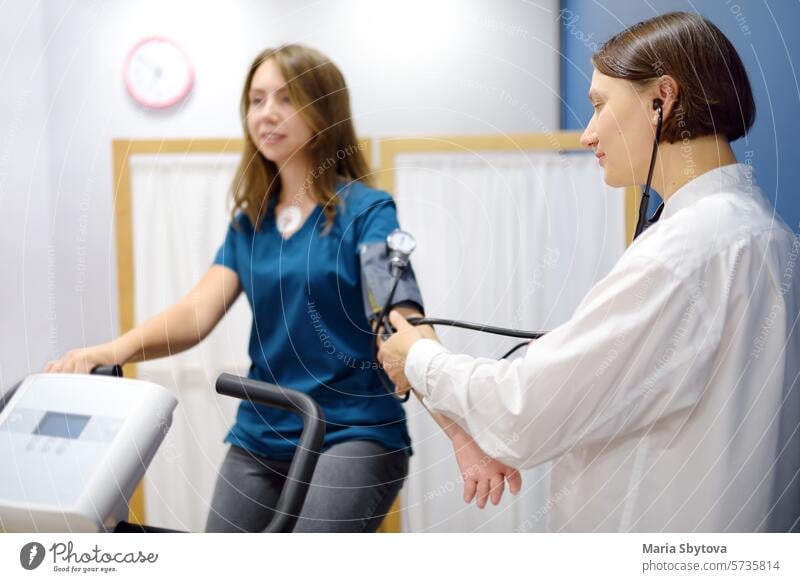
<box><xmin>451</xmin><ymin>430</ymin><xmax>522</xmax><ymax>509</ymax></box>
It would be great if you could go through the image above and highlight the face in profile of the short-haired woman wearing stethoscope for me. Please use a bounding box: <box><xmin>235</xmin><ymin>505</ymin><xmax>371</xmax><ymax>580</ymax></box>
<box><xmin>581</xmin><ymin>70</ymin><xmax>656</xmax><ymax>187</ymax></box>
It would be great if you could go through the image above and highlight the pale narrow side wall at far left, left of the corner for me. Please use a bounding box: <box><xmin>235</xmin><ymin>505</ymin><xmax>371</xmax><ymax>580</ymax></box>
<box><xmin>0</xmin><ymin>2</ymin><xmax>56</xmax><ymax>396</ymax></box>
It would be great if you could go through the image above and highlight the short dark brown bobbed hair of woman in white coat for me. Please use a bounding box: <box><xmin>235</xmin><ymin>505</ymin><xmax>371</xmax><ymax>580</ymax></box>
<box><xmin>592</xmin><ymin>12</ymin><xmax>756</xmax><ymax>143</ymax></box>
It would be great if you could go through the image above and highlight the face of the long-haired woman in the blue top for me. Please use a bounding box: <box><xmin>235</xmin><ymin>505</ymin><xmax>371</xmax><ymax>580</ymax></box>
<box><xmin>247</xmin><ymin>59</ymin><xmax>313</xmax><ymax>164</ymax></box>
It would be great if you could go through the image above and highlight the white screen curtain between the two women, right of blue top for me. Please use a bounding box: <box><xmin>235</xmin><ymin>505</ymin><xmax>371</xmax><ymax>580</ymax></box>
<box><xmin>395</xmin><ymin>152</ymin><xmax>625</xmax><ymax>532</ymax></box>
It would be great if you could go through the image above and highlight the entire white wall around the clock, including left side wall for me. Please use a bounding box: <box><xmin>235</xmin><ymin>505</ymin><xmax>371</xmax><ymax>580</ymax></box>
<box><xmin>0</xmin><ymin>0</ymin><xmax>559</xmax><ymax>532</ymax></box>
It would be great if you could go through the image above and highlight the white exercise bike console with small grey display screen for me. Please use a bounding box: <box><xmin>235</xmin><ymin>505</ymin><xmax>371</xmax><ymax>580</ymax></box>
<box><xmin>0</xmin><ymin>374</ymin><xmax>178</xmax><ymax>532</ymax></box>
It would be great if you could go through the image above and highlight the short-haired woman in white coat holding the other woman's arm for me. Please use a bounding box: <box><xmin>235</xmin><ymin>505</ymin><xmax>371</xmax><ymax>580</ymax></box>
<box><xmin>380</xmin><ymin>13</ymin><xmax>800</xmax><ymax>532</ymax></box>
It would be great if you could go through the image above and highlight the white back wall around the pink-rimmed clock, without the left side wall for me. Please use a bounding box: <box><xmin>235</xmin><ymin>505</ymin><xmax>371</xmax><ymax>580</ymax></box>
<box><xmin>34</xmin><ymin>0</ymin><xmax>558</xmax><ymax>355</ymax></box>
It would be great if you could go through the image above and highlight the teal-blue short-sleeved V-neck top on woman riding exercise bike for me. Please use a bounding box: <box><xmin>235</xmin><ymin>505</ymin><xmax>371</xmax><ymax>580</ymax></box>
<box><xmin>214</xmin><ymin>182</ymin><xmax>411</xmax><ymax>459</ymax></box>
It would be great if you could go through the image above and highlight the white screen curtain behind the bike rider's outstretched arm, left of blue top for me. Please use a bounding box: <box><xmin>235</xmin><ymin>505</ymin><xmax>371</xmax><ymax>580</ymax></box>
<box><xmin>130</xmin><ymin>154</ymin><xmax>251</xmax><ymax>531</ymax></box>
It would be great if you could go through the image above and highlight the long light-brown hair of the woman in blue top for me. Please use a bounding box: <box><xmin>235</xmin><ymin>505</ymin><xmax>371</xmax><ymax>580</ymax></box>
<box><xmin>231</xmin><ymin>44</ymin><xmax>371</xmax><ymax>228</ymax></box>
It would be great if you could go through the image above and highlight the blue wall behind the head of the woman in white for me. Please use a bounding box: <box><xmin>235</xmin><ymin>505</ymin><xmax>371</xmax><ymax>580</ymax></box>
<box><xmin>560</xmin><ymin>0</ymin><xmax>800</xmax><ymax>232</ymax></box>
